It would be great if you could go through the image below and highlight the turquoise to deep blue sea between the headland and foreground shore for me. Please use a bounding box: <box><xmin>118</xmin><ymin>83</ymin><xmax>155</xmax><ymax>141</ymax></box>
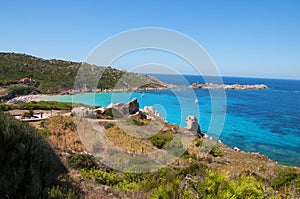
<box><xmin>41</xmin><ymin>75</ymin><xmax>300</xmax><ymax>166</ymax></box>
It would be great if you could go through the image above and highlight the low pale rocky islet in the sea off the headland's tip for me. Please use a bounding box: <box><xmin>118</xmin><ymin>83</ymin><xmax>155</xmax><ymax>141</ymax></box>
<box><xmin>190</xmin><ymin>83</ymin><xmax>268</xmax><ymax>90</ymax></box>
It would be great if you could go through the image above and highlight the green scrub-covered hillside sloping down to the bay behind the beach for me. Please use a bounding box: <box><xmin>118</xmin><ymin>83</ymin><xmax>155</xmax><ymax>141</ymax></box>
<box><xmin>0</xmin><ymin>53</ymin><xmax>168</xmax><ymax>95</ymax></box>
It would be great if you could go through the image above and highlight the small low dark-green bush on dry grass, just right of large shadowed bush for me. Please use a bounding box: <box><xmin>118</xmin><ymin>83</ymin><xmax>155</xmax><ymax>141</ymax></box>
<box><xmin>67</xmin><ymin>154</ymin><xmax>98</xmax><ymax>169</ymax></box>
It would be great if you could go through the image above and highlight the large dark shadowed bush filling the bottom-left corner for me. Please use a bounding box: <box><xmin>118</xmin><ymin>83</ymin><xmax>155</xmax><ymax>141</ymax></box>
<box><xmin>0</xmin><ymin>112</ymin><xmax>65</xmax><ymax>198</ymax></box>
